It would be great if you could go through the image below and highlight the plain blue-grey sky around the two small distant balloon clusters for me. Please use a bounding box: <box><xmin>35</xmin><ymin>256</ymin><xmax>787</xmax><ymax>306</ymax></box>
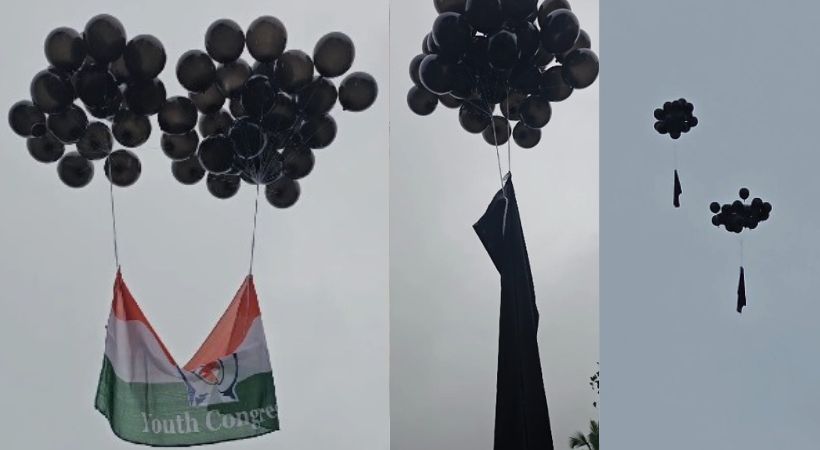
<box><xmin>601</xmin><ymin>0</ymin><xmax>820</xmax><ymax>450</ymax></box>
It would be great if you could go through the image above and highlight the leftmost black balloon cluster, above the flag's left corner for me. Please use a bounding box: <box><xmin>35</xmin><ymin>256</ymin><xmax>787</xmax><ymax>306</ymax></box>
<box><xmin>9</xmin><ymin>14</ymin><xmax>166</xmax><ymax>188</ymax></box>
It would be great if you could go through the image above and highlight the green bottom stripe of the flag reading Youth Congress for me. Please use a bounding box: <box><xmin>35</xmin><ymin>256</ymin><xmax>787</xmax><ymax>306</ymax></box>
<box><xmin>95</xmin><ymin>357</ymin><xmax>279</xmax><ymax>447</ymax></box>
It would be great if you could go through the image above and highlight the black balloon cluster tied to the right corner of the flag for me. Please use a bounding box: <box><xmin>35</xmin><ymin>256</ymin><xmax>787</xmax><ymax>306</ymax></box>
<box><xmin>174</xmin><ymin>16</ymin><xmax>378</xmax><ymax>208</ymax></box>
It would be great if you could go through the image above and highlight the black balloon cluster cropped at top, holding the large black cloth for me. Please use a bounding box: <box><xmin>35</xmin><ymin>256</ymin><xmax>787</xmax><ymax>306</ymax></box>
<box><xmin>407</xmin><ymin>0</ymin><xmax>598</xmax><ymax>148</ymax></box>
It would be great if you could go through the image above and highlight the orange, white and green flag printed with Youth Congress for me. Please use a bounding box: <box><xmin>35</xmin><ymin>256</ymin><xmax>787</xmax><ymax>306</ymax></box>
<box><xmin>96</xmin><ymin>272</ymin><xmax>279</xmax><ymax>447</ymax></box>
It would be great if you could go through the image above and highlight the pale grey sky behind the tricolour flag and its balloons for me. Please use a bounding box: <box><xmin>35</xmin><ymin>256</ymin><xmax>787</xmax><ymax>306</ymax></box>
<box><xmin>0</xmin><ymin>0</ymin><xmax>389</xmax><ymax>450</ymax></box>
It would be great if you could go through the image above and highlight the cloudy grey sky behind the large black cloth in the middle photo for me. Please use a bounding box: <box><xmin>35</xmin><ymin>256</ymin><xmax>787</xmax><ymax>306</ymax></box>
<box><xmin>390</xmin><ymin>0</ymin><xmax>598</xmax><ymax>450</ymax></box>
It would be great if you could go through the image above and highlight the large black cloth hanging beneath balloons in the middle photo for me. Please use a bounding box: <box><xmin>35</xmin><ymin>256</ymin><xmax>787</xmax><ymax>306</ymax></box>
<box><xmin>473</xmin><ymin>174</ymin><xmax>554</xmax><ymax>450</ymax></box>
